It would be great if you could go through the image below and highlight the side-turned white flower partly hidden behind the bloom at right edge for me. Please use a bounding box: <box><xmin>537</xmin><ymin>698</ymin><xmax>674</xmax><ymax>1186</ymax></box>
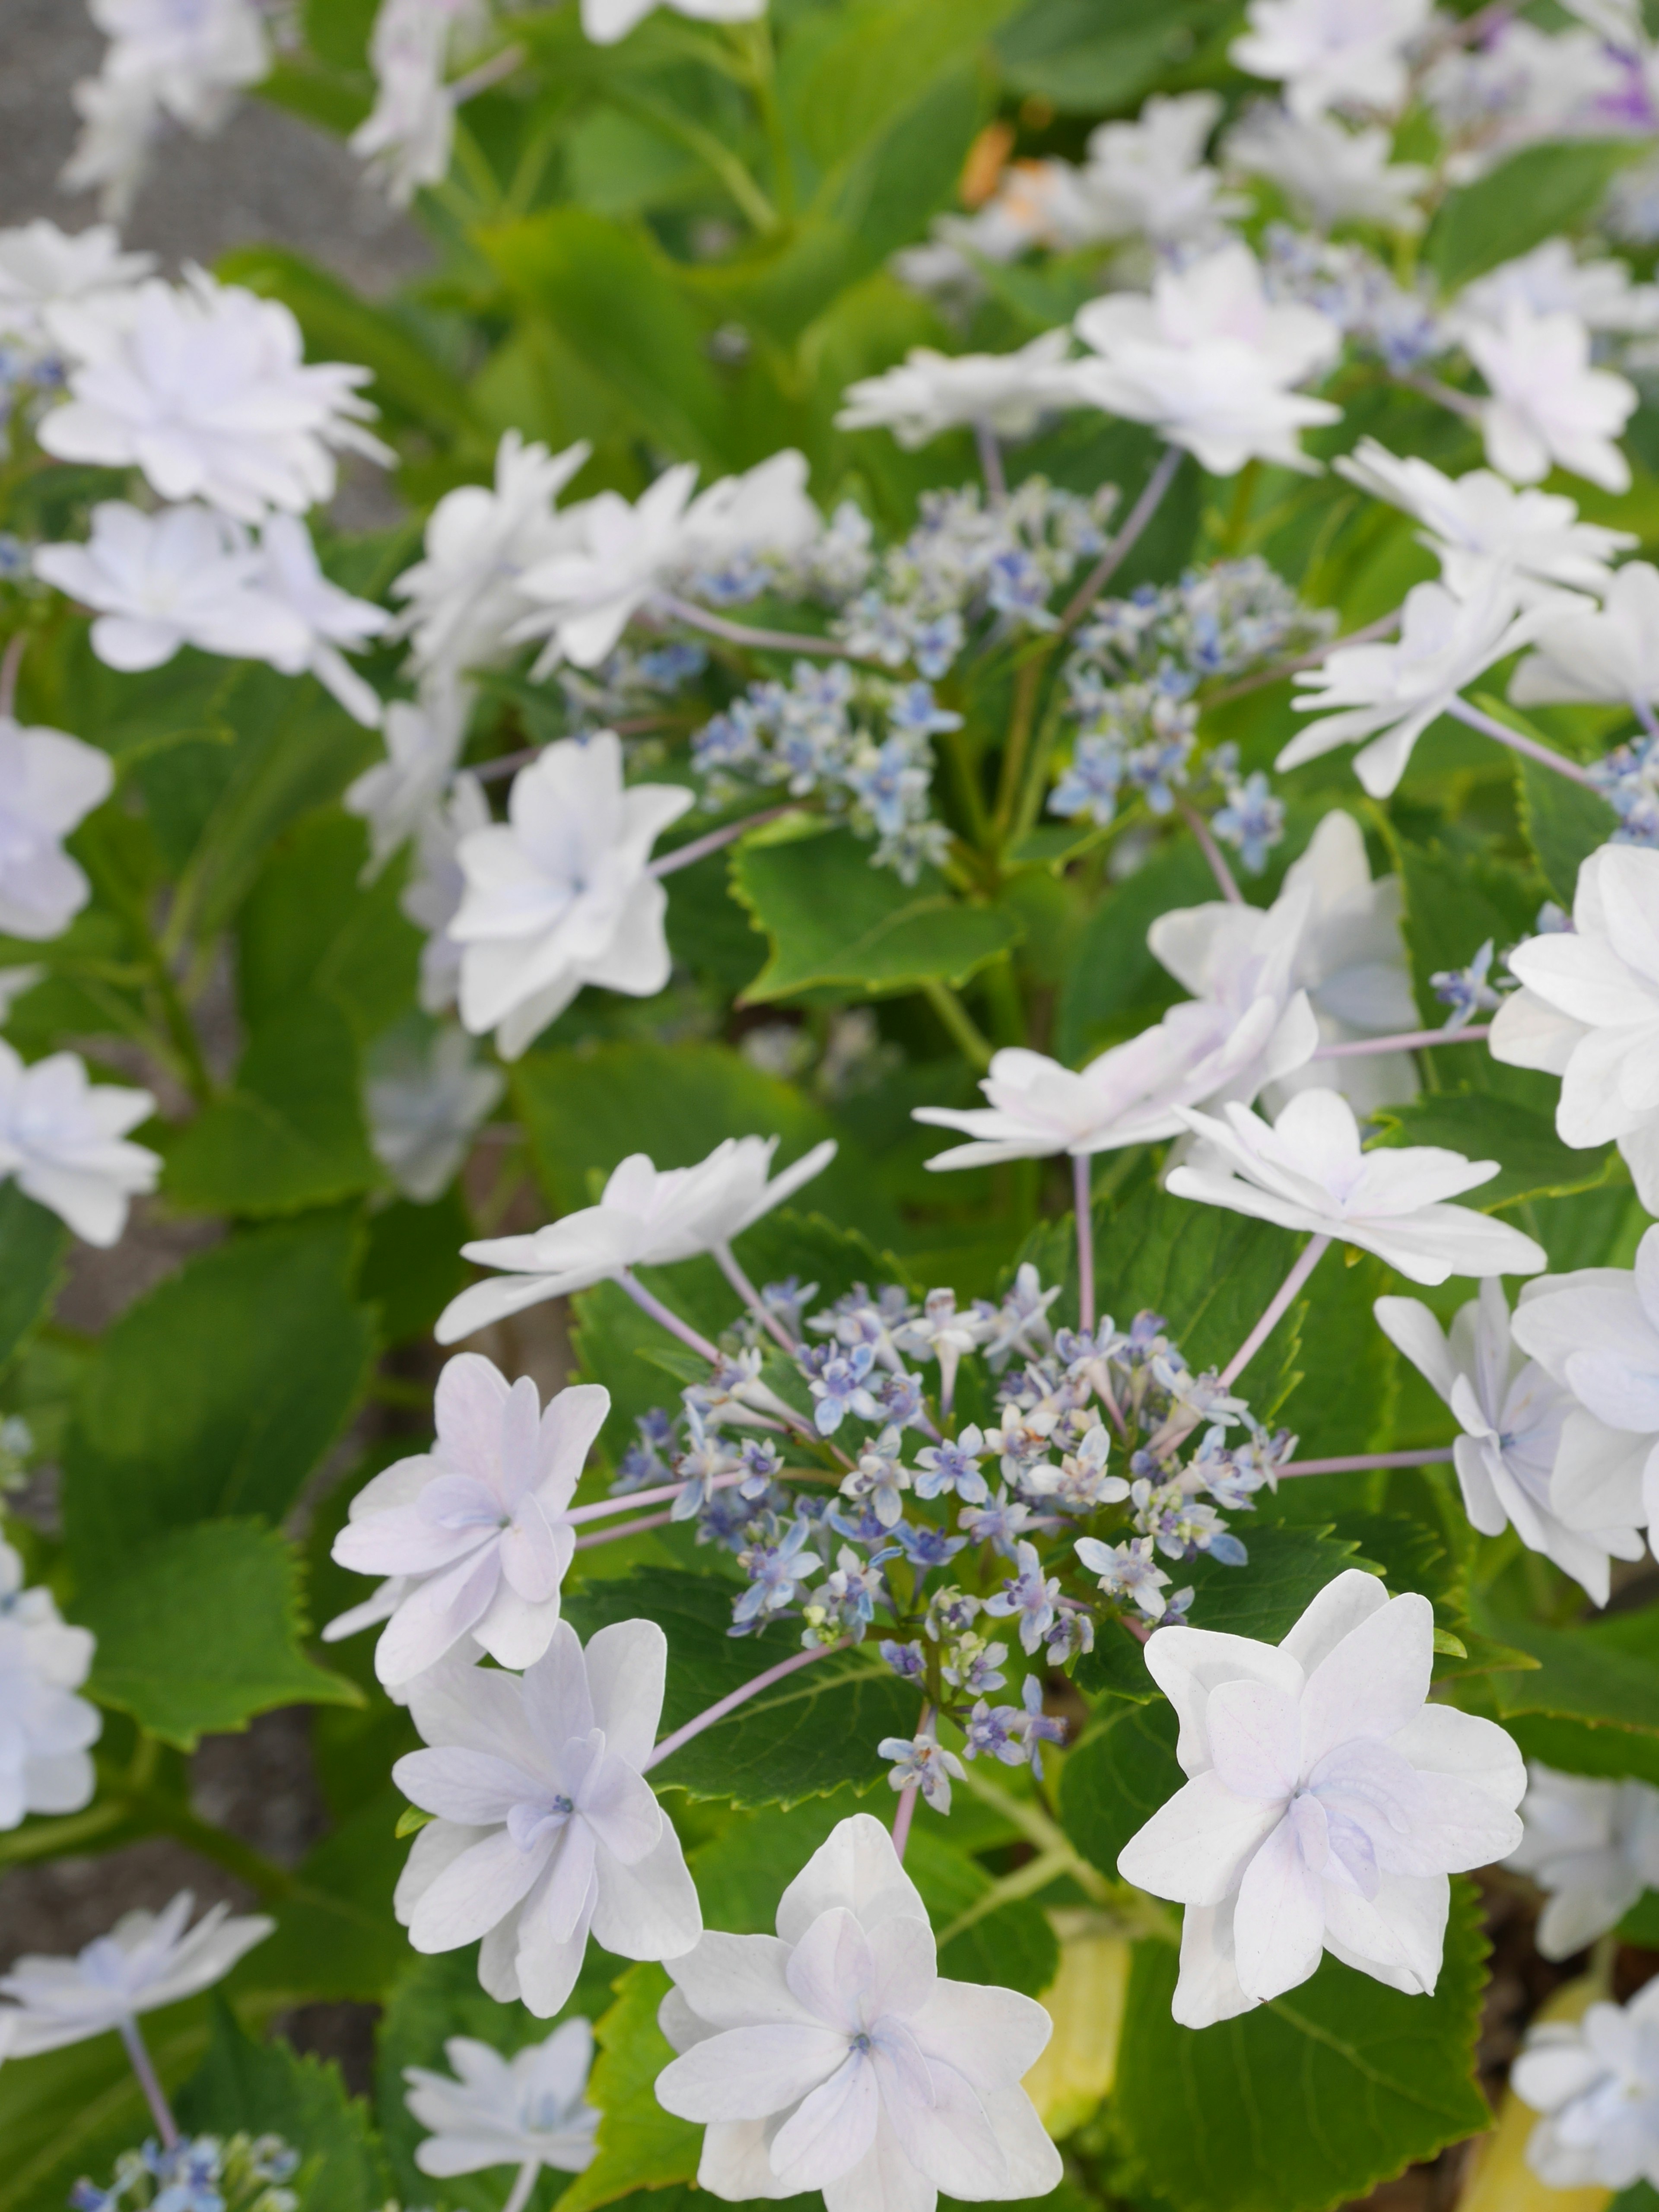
<box><xmin>1376</xmin><ymin>1278</ymin><xmax>1643</xmax><ymax>1610</ymax></box>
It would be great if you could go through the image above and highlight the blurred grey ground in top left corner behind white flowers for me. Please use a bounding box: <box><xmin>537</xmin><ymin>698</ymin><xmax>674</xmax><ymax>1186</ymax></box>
<box><xmin>0</xmin><ymin>0</ymin><xmax>427</xmax><ymax>292</ymax></box>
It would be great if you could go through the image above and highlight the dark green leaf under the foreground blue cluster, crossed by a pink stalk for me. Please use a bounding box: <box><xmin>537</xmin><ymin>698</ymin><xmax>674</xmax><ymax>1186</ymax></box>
<box><xmin>564</xmin><ymin>1568</ymin><xmax>918</xmax><ymax>1805</ymax></box>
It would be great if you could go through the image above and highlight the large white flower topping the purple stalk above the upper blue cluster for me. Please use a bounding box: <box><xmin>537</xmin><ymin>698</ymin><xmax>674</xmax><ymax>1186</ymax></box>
<box><xmin>1073</xmin><ymin>243</ymin><xmax>1343</xmax><ymax>476</ymax></box>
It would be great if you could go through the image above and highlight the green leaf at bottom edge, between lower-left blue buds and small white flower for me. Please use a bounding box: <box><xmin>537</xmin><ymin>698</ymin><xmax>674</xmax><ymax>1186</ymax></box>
<box><xmin>179</xmin><ymin>1997</ymin><xmax>391</xmax><ymax>2212</ymax></box>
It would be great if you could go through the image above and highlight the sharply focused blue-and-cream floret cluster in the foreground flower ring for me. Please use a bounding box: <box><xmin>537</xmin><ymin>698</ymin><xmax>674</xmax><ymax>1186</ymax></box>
<box><xmin>597</xmin><ymin>1263</ymin><xmax>1294</xmax><ymax>1809</ymax></box>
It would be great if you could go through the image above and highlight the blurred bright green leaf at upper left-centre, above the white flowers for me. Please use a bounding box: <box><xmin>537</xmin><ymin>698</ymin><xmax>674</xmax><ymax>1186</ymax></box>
<box><xmin>478</xmin><ymin>206</ymin><xmax>730</xmax><ymax>476</ymax></box>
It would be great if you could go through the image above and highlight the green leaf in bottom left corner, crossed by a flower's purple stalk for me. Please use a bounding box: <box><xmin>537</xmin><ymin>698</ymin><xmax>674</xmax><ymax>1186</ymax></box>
<box><xmin>0</xmin><ymin>1997</ymin><xmax>208</xmax><ymax>2212</ymax></box>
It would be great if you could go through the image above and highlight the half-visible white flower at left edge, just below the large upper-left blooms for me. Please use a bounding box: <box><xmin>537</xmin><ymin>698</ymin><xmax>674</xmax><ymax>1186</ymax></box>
<box><xmin>0</xmin><ymin>715</ymin><xmax>115</xmax><ymax>940</ymax></box>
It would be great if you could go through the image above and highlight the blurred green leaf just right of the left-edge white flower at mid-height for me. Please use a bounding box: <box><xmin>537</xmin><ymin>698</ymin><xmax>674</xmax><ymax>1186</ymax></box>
<box><xmin>164</xmin><ymin>998</ymin><xmax>381</xmax><ymax>1219</ymax></box>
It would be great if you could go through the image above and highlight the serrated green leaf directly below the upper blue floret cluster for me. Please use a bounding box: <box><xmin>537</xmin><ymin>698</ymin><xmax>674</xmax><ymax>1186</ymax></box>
<box><xmin>732</xmin><ymin>823</ymin><xmax>1020</xmax><ymax>1002</ymax></box>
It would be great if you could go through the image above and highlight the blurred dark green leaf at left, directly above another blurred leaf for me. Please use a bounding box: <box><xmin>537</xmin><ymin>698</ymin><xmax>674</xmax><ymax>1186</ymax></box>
<box><xmin>237</xmin><ymin>814</ymin><xmax>420</xmax><ymax>1044</ymax></box>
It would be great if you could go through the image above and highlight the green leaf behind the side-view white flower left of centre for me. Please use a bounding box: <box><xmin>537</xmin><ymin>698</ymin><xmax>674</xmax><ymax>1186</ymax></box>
<box><xmin>513</xmin><ymin>1042</ymin><xmax>898</xmax><ymax>1272</ymax></box>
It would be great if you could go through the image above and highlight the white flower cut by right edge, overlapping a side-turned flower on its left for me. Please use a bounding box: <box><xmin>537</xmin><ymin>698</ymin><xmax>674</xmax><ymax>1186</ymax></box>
<box><xmin>1511</xmin><ymin>1230</ymin><xmax>1659</xmax><ymax>1544</ymax></box>
